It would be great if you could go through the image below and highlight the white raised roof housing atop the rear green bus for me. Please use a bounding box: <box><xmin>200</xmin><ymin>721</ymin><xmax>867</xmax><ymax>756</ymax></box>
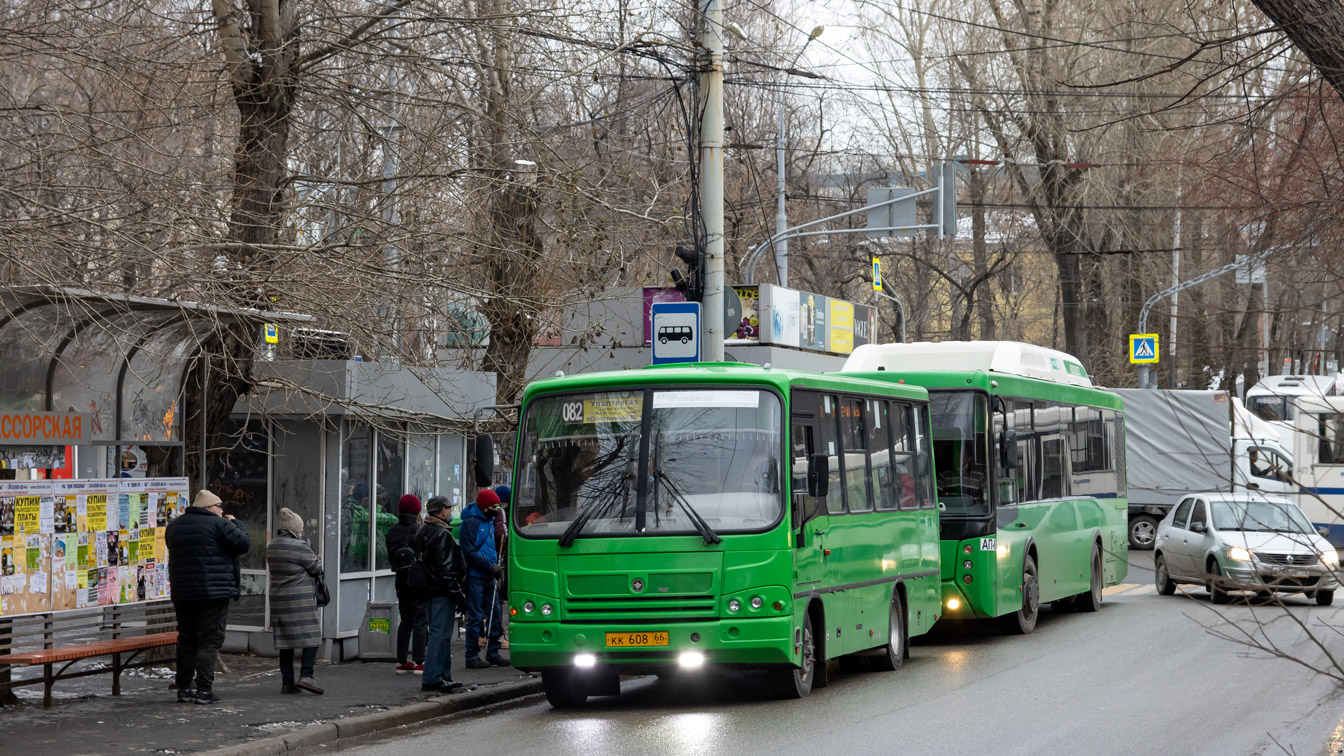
<box><xmin>840</xmin><ymin>342</ymin><xmax>1093</xmax><ymax>387</ymax></box>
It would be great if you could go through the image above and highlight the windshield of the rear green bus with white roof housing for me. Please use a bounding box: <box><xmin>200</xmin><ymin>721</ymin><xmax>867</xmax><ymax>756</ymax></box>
<box><xmin>929</xmin><ymin>391</ymin><xmax>989</xmax><ymax>517</ymax></box>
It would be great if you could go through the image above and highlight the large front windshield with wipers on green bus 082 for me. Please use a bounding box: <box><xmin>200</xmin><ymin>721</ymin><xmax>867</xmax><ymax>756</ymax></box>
<box><xmin>513</xmin><ymin>389</ymin><xmax>784</xmax><ymax>541</ymax></box>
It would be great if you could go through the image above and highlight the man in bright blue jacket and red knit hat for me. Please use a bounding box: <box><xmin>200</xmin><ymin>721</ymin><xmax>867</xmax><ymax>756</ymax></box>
<box><xmin>462</xmin><ymin>488</ymin><xmax>509</xmax><ymax>670</ymax></box>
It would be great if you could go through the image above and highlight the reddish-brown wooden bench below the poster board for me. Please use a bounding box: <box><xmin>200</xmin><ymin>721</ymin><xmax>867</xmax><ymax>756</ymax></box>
<box><xmin>0</xmin><ymin>601</ymin><xmax>177</xmax><ymax>708</ymax></box>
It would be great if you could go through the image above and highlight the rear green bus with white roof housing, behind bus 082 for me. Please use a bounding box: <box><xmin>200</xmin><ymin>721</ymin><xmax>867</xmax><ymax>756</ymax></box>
<box><xmin>841</xmin><ymin>342</ymin><xmax>1129</xmax><ymax>634</ymax></box>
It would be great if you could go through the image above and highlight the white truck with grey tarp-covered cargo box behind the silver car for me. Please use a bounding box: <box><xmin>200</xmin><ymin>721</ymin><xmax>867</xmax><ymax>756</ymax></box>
<box><xmin>1114</xmin><ymin>389</ymin><xmax>1290</xmax><ymax>550</ymax></box>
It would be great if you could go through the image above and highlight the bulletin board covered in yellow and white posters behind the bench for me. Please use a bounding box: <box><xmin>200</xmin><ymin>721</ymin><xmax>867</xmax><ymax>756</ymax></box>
<box><xmin>0</xmin><ymin>478</ymin><xmax>188</xmax><ymax>616</ymax></box>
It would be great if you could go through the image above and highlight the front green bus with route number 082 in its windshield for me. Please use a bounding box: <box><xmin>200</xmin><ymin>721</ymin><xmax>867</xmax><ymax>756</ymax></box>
<box><xmin>508</xmin><ymin>363</ymin><xmax>941</xmax><ymax>706</ymax></box>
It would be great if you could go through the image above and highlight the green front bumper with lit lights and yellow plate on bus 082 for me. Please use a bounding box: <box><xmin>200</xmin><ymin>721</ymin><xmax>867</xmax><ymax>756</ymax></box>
<box><xmin>508</xmin><ymin>615</ymin><xmax>797</xmax><ymax>674</ymax></box>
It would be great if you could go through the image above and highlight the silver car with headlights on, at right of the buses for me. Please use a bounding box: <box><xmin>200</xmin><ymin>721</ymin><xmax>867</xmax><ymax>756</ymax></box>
<box><xmin>1153</xmin><ymin>494</ymin><xmax>1340</xmax><ymax>607</ymax></box>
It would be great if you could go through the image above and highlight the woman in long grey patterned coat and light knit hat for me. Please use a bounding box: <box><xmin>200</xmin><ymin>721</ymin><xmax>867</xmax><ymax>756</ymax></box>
<box><xmin>266</xmin><ymin>508</ymin><xmax>323</xmax><ymax>694</ymax></box>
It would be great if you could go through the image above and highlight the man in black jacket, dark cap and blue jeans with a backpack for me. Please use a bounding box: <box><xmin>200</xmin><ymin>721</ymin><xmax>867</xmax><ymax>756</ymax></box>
<box><xmin>415</xmin><ymin>496</ymin><xmax>466</xmax><ymax>693</ymax></box>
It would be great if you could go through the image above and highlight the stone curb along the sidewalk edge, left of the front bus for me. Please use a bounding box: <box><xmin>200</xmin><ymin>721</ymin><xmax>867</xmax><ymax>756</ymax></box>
<box><xmin>198</xmin><ymin>679</ymin><xmax>542</xmax><ymax>756</ymax></box>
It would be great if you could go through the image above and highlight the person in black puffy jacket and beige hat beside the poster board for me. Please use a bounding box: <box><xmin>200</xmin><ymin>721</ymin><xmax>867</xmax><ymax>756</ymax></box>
<box><xmin>164</xmin><ymin>490</ymin><xmax>251</xmax><ymax>704</ymax></box>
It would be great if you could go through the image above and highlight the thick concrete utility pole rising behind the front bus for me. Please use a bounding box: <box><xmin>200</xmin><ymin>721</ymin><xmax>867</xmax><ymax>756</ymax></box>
<box><xmin>700</xmin><ymin>0</ymin><xmax>723</xmax><ymax>362</ymax></box>
